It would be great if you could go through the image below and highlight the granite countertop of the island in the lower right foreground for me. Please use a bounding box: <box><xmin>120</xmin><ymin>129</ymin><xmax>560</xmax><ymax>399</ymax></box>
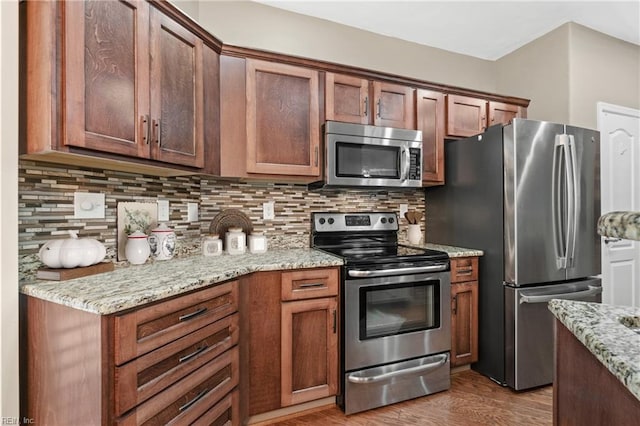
<box><xmin>549</xmin><ymin>299</ymin><xmax>640</xmax><ymax>400</ymax></box>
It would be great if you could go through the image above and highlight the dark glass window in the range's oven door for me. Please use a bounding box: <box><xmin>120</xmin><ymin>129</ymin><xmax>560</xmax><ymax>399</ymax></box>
<box><xmin>360</xmin><ymin>280</ymin><xmax>440</xmax><ymax>340</ymax></box>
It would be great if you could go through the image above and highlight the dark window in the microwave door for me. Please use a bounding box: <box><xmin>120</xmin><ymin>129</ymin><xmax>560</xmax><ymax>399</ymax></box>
<box><xmin>335</xmin><ymin>142</ymin><xmax>400</xmax><ymax>179</ymax></box>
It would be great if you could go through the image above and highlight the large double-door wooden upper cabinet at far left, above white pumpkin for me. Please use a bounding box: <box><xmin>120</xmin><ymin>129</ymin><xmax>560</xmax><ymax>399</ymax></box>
<box><xmin>21</xmin><ymin>1</ymin><xmax>219</xmax><ymax>175</ymax></box>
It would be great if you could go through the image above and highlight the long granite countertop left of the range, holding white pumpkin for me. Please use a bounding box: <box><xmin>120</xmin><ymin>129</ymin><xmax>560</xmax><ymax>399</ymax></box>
<box><xmin>20</xmin><ymin>248</ymin><xmax>343</xmax><ymax>315</ymax></box>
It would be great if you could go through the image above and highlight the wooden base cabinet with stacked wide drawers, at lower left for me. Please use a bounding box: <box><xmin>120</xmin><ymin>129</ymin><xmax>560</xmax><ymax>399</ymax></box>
<box><xmin>21</xmin><ymin>281</ymin><xmax>240</xmax><ymax>426</ymax></box>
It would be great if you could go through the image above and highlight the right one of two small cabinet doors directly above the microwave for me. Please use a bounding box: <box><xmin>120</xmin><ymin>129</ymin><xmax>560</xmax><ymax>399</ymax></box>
<box><xmin>371</xmin><ymin>81</ymin><xmax>416</xmax><ymax>129</ymax></box>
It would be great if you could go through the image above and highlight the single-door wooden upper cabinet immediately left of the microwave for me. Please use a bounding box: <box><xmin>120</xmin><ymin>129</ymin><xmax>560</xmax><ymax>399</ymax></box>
<box><xmin>220</xmin><ymin>56</ymin><xmax>320</xmax><ymax>181</ymax></box>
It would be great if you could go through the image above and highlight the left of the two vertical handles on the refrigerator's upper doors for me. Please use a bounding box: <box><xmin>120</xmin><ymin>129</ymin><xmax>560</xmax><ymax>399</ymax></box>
<box><xmin>551</xmin><ymin>134</ymin><xmax>567</xmax><ymax>269</ymax></box>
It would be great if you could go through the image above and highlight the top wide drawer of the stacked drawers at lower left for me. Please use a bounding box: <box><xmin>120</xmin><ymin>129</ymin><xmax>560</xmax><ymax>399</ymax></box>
<box><xmin>114</xmin><ymin>281</ymin><xmax>238</xmax><ymax>365</ymax></box>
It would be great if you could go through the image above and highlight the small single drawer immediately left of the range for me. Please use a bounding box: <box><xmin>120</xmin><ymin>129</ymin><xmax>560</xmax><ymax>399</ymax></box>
<box><xmin>281</xmin><ymin>268</ymin><xmax>339</xmax><ymax>300</ymax></box>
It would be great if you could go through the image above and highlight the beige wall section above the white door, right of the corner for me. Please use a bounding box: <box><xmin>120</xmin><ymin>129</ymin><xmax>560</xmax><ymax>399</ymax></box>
<box><xmin>569</xmin><ymin>24</ymin><xmax>640</xmax><ymax>129</ymax></box>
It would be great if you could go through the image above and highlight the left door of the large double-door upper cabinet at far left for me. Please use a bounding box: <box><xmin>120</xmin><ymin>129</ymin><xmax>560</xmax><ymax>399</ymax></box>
<box><xmin>63</xmin><ymin>1</ymin><xmax>149</xmax><ymax>157</ymax></box>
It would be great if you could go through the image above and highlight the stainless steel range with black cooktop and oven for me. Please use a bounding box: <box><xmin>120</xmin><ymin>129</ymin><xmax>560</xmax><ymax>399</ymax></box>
<box><xmin>312</xmin><ymin>213</ymin><xmax>451</xmax><ymax>414</ymax></box>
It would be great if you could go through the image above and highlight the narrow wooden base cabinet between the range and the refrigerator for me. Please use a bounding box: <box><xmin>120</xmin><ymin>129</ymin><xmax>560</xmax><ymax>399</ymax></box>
<box><xmin>451</xmin><ymin>257</ymin><xmax>478</xmax><ymax>367</ymax></box>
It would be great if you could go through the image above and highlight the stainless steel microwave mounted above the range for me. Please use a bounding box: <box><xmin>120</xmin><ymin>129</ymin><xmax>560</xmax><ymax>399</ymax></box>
<box><xmin>314</xmin><ymin>121</ymin><xmax>422</xmax><ymax>188</ymax></box>
